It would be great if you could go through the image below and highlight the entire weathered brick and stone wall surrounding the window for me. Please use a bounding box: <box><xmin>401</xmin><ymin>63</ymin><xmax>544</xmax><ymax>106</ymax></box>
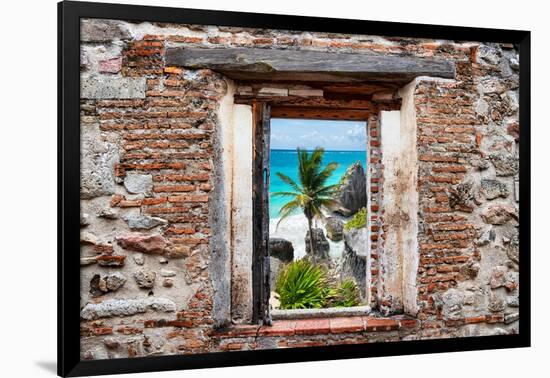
<box><xmin>80</xmin><ymin>20</ymin><xmax>519</xmax><ymax>359</ymax></box>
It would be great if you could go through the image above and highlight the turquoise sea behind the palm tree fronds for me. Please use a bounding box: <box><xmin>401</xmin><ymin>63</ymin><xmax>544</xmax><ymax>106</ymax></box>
<box><xmin>269</xmin><ymin>150</ymin><xmax>367</xmax><ymax>219</ymax></box>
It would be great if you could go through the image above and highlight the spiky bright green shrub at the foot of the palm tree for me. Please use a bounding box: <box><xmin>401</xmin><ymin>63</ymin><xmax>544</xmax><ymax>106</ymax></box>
<box><xmin>275</xmin><ymin>259</ymin><xmax>334</xmax><ymax>309</ymax></box>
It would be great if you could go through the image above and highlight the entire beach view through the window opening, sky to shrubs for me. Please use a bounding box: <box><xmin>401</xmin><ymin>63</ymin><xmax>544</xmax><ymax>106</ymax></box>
<box><xmin>267</xmin><ymin>118</ymin><xmax>368</xmax><ymax>310</ymax></box>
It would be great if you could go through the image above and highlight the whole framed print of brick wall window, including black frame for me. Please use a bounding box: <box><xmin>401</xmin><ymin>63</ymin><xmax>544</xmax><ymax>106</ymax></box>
<box><xmin>58</xmin><ymin>2</ymin><xmax>530</xmax><ymax>376</ymax></box>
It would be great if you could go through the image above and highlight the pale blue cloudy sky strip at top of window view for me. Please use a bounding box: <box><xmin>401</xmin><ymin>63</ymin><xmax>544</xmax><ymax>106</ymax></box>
<box><xmin>271</xmin><ymin>118</ymin><xmax>367</xmax><ymax>151</ymax></box>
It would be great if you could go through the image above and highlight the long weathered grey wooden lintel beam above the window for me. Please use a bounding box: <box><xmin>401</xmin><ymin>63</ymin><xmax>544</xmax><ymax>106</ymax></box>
<box><xmin>166</xmin><ymin>47</ymin><xmax>455</xmax><ymax>83</ymax></box>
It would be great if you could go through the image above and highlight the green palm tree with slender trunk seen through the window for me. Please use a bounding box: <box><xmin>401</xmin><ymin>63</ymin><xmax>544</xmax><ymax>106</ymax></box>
<box><xmin>272</xmin><ymin>147</ymin><xmax>340</xmax><ymax>262</ymax></box>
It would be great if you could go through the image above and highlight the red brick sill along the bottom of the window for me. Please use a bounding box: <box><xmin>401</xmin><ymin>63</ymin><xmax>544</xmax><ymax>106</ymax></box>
<box><xmin>216</xmin><ymin>316</ymin><xmax>419</xmax><ymax>338</ymax></box>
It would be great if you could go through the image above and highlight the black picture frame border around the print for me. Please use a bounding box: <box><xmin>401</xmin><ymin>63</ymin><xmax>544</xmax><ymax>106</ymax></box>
<box><xmin>57</xmin><ymin>1</ymin><xmax>531</xmax><ymax>376</ymax></box>
